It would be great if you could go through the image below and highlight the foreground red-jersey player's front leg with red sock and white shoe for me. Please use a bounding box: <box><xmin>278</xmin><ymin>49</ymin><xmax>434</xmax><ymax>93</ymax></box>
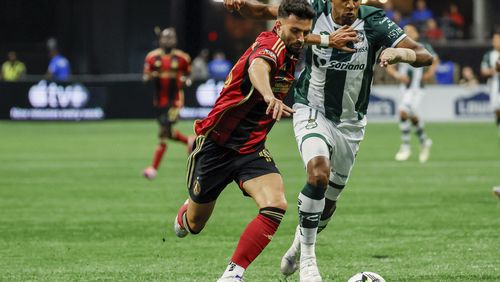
<box><xmin>219</xmin><ymin>173</ymin><xmax>287</xmax><ymax>281</ymax></box>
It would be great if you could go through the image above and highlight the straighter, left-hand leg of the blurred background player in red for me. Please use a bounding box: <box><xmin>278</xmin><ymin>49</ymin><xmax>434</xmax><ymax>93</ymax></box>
<box><xmin>143</xmin><ymin>108</ymin><xmax>171</xmax><ymax>180</ymax></box>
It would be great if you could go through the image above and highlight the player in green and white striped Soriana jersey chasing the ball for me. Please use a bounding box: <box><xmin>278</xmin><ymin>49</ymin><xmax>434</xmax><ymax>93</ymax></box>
<box><xmin>224</xmin><ymin>0</ymin><xmax>433</xmax><ymax>281</ymax></box>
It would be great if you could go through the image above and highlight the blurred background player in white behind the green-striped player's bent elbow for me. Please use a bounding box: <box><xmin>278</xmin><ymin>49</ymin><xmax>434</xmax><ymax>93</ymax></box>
<box><xmin>387</xmin><ymin>24</ymin><xmax>439</xmax><ymax>163</ymax></box>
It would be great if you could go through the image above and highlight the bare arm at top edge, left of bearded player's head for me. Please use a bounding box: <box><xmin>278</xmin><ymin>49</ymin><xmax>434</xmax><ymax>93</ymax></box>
<box><xmin>224</xmin><ymin>0</ymin><xmax>278</xmax><ymax>20</ymax></box>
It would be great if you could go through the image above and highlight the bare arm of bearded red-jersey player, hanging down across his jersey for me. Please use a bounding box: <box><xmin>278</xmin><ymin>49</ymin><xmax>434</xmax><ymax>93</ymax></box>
<box><xmin>248</xmin><ymin>58</ymin><xmax>294</xmax><ymax>120</ymax></box>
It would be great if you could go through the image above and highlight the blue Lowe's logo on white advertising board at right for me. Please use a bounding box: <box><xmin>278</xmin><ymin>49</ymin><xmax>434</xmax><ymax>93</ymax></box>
<box><xmin>455</xmin><ymin>92</ymin><xmax>491</xmax><ymax>117</ymax></box>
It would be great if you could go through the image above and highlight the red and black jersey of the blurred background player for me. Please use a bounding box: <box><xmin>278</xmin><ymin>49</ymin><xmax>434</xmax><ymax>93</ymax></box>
<box><xmin>144</xmin><ymin>48</ymin><xmax>191</xmax><ymax>107</ymax></box>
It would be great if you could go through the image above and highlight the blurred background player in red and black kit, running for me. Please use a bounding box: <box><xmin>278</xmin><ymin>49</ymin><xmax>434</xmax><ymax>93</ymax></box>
<box><xmin>143</xmin><ymin>28</ymin><xmax>194</xmax><ymax>180</ymax></box>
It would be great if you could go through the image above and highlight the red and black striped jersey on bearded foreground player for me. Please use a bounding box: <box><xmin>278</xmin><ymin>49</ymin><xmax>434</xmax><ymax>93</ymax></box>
<box><xmin>195</xmin><ymin>30</ymin><xmax>297</xmax><ymax>154</ymax></box>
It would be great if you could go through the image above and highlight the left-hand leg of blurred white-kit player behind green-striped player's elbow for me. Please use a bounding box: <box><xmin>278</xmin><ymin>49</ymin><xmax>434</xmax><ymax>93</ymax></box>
<box><xmin>394</xmin><ymin>90</ymin><xmax>413</xmax><ymax>161</ymax></box>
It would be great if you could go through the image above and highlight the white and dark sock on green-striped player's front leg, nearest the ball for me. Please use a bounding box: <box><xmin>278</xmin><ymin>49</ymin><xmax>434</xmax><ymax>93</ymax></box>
<box><xmin>299</xmin><ymin>183</ymin><xmax>325</xmax><ymax>257</ymax></box>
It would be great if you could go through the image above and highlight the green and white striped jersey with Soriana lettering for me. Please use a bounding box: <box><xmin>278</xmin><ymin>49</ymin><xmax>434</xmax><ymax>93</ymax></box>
<box><xmin>294</xmin><ymin>0</ymin><xmax>406</xmax><ymax>122</ymax></box>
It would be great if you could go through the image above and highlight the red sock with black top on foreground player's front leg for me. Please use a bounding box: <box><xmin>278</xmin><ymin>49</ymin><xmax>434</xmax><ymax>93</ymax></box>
<box><xmin>231</xmin><ymin>207</ymin><xmax>285</xmax><ymax>269</ymax></box>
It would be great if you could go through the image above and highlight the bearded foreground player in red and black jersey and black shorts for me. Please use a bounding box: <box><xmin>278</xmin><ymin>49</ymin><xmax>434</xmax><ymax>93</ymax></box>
<box><xmin>174</xmin><ymin>0</ymin><xmax>315</xmax><ymax>281</ymax></box>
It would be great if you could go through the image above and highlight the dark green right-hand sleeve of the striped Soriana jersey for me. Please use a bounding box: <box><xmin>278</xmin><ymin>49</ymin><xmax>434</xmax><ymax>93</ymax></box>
<box><xmin>366</xmin><ymin>10</ymin><xmax>406</xmax><ymax>47</ymax></box>
